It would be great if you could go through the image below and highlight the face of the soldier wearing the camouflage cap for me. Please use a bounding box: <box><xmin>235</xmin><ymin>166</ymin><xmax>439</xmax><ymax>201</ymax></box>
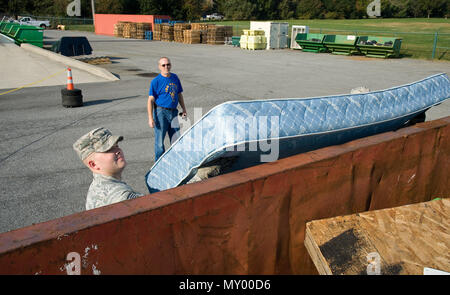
<box><xmin>94</xmin><ymin>144</ymin><xmax>127</xmax><ymax>176</ymax></box>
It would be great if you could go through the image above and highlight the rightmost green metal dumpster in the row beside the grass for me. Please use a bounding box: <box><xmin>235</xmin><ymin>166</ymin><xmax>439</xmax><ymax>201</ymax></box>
<box><xmin>356</xmin><ymin>36</ymin><xmax>402</xmax><ymax>58</ymax></box>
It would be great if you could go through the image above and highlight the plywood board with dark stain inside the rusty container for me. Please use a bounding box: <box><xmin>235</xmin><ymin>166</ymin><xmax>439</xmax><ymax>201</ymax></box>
<box><xmin>305</xmin><ymin>199</ymin><xmax>450</xmax><ymax>275</ymax></box>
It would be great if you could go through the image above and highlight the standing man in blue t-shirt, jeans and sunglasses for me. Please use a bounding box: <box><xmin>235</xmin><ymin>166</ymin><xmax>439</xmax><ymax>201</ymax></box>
<box><xmin>147</xmin><ymin>57</ymin><xmax>187</xmax><ymax>162</ymax></box>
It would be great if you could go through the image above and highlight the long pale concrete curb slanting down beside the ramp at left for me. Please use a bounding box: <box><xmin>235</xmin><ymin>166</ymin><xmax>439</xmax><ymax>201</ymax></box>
<box><xmin>20</xmin><ymin>43</ymin><xmax>120</xmax><ymax>81</ymax></box>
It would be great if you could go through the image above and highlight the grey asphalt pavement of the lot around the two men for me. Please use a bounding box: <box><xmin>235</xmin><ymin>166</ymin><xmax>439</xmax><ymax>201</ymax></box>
<box><xmin>0</xmin><ymin>30</ymin><xmax>450</xmax><ymax>232</ymax></box>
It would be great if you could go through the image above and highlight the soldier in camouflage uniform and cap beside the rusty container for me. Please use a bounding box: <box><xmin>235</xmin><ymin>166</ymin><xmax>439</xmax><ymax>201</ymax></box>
<box><xmin>73</xmin><ymin>127</ymin><xmax>143</xmax><ymax>210</ymax></box>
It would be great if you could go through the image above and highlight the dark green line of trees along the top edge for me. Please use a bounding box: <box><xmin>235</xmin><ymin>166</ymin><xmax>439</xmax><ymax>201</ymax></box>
<box><xmin>0</xmin><ymin>0</ymin><xmax>450</xmax><ymax>20</ymax></box>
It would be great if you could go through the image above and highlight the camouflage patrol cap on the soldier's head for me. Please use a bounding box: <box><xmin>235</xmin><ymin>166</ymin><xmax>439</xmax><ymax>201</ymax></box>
<box><xmin>73</xmin><ymin>127</ymin><xmax>123</xmax><ymax>161</ymax></box>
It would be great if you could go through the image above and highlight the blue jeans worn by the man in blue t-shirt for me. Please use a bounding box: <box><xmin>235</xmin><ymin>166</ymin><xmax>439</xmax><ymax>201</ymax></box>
<box><xmin>153</xmin><ymin>106</ymin><xmax>180</xmax><ymax>162</ymax></box>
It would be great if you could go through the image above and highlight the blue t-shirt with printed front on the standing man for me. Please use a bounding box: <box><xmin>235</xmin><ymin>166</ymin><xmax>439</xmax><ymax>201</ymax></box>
<box><xmin>148</xmin><ymin>73</ymin><xmax>183</xmax><ymax>109</ymax></box>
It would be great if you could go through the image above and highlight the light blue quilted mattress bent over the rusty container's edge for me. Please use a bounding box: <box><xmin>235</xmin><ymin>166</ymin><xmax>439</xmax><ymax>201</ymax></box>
<box><xmin>145</xmin><ymin>73</ymin><xmax>450</xmax><ymax>193</ymax></box>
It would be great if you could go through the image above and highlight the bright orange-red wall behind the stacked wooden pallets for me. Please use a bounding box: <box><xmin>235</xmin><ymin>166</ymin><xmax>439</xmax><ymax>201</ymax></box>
<box><xmin>94</xmin><ymin>14</ymin><xmax>170</xmax><ymax>36</ymax></box>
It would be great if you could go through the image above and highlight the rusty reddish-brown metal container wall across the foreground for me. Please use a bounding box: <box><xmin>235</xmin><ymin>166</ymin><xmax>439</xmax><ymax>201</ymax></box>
<box><xmin>0</xmin><ymin>117</ymin><xmax>450</xmax><ymax>274</ymax></box>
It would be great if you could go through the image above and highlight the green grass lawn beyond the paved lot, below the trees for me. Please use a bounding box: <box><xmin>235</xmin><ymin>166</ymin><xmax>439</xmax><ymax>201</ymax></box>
<box><xmin>66</xmin><ymin>18</ymin><xmax>450</xmax><ymax>61</ymax></box>
